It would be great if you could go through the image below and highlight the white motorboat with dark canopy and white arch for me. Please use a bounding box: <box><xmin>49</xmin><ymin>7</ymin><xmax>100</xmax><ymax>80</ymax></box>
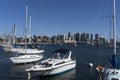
<box><xmin>26</xmin><ymin>49</ymin><xmax>76</xmax><ymax>77</ymax></box>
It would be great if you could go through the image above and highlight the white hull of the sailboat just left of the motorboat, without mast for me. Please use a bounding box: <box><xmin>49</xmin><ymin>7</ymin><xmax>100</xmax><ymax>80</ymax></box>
<box><xmin>10</xmin><ymin>55</ymin><xmax>43</xmax><ymax>64</ymax></box>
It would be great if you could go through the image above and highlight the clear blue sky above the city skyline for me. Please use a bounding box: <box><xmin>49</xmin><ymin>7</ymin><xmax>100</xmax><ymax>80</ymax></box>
<box><xmin>0</xmin><ymin>0</ymin><xmax>120</xmax><ymax>38</ymax></box>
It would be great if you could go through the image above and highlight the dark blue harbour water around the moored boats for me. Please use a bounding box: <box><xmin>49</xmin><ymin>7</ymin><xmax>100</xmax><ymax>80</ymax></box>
<box><xmin>0</xmin><ymin>44</ymin><xmax>120</xmax><ymax>80</ymax></box>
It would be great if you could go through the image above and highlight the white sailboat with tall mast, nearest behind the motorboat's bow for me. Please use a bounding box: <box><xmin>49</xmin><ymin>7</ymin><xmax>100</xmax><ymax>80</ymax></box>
<box><xmin>10</xmin><ymin>6</ymin><xmax>43</xmax><ymax>64</ymax></box>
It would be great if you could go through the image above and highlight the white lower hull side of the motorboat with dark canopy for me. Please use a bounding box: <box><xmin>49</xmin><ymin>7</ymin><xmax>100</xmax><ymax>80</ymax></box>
<box><xmin>28</xmin><ymin>61</ymin><xmax>76</xmax><ymax>77</ymax></box>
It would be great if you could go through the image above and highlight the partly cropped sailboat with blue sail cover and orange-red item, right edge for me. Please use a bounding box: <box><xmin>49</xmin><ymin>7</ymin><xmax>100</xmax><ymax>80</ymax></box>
<box><xmin>98</xmin><ymin>0</ymin><xmax>120</xmax><ymax>80</ymax></box>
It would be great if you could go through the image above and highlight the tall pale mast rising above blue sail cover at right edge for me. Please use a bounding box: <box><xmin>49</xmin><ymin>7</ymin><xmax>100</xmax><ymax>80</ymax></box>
<box><xmin>113</xmin><ymin>0</ymin><xmax>116</xmax><ymax>55</ymax></box>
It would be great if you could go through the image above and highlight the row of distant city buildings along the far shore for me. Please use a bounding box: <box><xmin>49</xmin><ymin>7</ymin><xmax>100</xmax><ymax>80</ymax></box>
<box><xmin>0</xmin><ymin>32</ymin><xmax>108</xmax><ymax>44</ymax></box>
